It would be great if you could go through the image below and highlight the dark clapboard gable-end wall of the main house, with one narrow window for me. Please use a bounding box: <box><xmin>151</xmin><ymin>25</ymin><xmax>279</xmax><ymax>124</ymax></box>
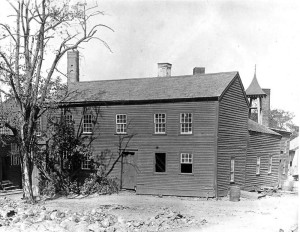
<box><xmin>217</xmin><ymin>76</ymin><xmax>248</xmax><ymax>196</ymax></box>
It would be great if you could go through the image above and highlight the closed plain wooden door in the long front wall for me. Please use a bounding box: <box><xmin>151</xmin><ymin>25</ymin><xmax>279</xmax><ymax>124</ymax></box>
<box><xmin>121</xmin><ymin>152</ymin><xmax>137</xmax><ymax>189</ymax></box>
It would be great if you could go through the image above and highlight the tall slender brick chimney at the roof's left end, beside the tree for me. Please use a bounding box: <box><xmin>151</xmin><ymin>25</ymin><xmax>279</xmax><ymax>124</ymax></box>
<box><xmin>67</xmin><ymin>50</ymin><xmax>79</xmax><ymax>85</ymax></box>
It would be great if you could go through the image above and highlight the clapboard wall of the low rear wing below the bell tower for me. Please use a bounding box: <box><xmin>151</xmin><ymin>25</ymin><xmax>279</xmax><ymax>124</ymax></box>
<box><xmin>245</xmin><ymin>131</ymin><xmax>280</xmax><ymax>190</ymax></box>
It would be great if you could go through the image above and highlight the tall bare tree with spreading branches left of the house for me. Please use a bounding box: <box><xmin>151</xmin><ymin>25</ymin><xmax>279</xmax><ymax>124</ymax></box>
<box><xmin>0</xmin><ymin>0</ymin><xmax>111</xmax><ymax>202</ymax></box>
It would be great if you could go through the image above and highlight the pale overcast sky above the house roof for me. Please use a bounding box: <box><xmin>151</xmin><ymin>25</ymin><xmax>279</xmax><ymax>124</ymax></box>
<box><xmin>0</xmin><ymin>0</ymin><xmax>300</xmax><ymax>125</ymax></box>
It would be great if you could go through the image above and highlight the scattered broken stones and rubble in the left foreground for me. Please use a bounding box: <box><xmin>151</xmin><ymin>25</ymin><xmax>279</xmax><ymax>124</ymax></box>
<box><xmin>0</xmin><ymin>198</ymin><xmax>206</xmax><ymax>232</ymax></box>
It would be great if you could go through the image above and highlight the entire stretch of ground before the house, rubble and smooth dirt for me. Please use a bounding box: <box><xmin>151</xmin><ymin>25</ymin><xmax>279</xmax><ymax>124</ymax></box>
<box><xmin>0</xmin><ymin>192</ymin><xmax>298</xmax><ymax>232</ymax></box>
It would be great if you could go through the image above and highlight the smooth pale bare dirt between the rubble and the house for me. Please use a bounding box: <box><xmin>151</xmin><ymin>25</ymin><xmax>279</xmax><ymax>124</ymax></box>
<box><xmin>8</xmin><ymin>192</ymin><xmax>299</xmax><ymax>232</ymax></box>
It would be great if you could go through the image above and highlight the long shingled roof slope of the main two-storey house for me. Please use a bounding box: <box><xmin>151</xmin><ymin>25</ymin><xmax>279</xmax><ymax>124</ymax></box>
<box><xmin>64</xmin><ymin>72</ymin><xmax>238</xmax><ymax>104</ymax></box>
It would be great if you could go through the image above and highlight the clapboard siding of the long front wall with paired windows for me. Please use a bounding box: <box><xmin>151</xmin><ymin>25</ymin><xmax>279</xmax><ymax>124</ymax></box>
<box><xmin>66</xmin><ymin>101</ymin><xmax>218</xmax><ymax>196</ymax></box>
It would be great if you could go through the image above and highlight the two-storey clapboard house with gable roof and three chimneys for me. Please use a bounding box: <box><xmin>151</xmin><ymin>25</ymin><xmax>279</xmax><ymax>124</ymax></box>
<box><xmin>62</xmin><ymin>51</ymin><xmax>248</xmax><ymax>197</ymax></box>
